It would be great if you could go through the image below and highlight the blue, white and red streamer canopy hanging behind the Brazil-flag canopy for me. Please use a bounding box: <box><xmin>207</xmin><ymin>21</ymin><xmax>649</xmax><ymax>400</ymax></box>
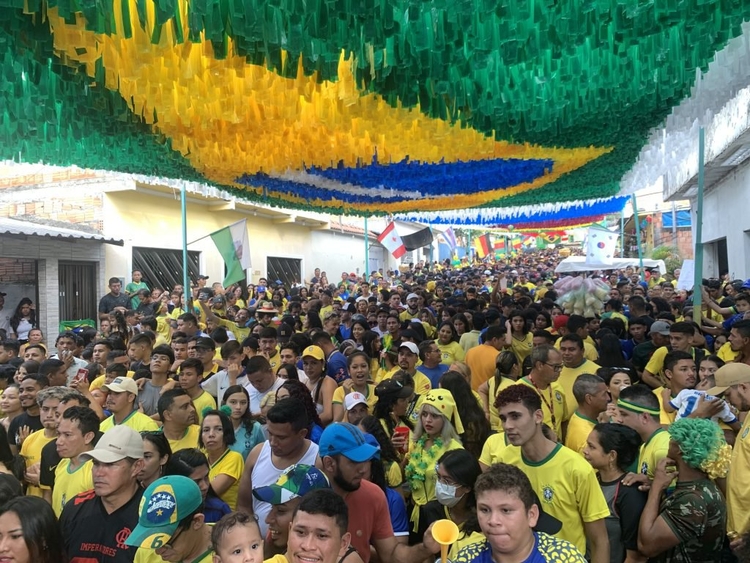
<box><xmin>396</xmin><ymin>196</ymin><xmax>630</xmax><ymax>231</ymax></box>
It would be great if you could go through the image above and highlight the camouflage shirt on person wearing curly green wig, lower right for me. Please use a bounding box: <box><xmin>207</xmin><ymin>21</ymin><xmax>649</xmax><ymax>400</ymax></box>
<box><xmin>652</xmin><ymin>479</ymin><xmax>727</xmax><ymax>563</ymax></box>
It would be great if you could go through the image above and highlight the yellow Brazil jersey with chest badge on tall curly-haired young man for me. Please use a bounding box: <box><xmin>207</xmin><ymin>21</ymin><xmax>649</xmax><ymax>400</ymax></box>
<box><xmin>498</xmin><ymin>444</ymin><xmax>610</xmax><ymax>553</ymax></box>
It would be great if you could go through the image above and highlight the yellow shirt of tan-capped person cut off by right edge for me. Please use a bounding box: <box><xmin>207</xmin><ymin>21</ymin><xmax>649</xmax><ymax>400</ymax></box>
<box><xmin>727</xmin><ymin>416</ymin><xmax>750</xmax><ymax>535</ymax></box>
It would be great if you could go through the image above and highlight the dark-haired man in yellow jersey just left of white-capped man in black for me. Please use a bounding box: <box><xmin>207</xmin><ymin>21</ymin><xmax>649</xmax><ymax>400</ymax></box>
<box><xmin>52</xmin><ymin>407</ymin><xmax>99</xmax><ymax>518</ymax></box>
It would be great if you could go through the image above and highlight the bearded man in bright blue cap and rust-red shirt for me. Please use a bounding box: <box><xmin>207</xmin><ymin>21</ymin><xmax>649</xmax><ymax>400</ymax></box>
<box><xmin>319</xmin><ymin>422</ymin><xmax>440</xmax><ymax>563</ymax></box>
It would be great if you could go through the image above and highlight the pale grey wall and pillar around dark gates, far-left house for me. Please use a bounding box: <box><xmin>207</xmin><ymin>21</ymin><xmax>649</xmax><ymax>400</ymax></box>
<box><xmin>0</xmin><ymin>236</ymin><xmax>110</xmax><ymax>344</ymax></box>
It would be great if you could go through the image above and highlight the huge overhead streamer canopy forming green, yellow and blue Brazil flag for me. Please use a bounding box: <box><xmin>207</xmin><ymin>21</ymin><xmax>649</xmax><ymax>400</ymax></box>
<box><xmin>0</xmin><ymin>0</ymin><xmax>750</xmax><ymax>214</ymax></box>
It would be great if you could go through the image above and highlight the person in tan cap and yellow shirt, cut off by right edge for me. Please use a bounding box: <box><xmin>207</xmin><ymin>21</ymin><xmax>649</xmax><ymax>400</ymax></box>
<box><xmin>708</xmin><ymin>363</ymin><xmax>750</xmax><ymax>536</ymax></box>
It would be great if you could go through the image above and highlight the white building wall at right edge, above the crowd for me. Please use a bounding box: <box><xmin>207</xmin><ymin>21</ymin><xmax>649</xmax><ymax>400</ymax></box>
<box><xmin>691</xmin><ymin>159</ymin><xmax>750</xmax><ymax>279</ymax></box>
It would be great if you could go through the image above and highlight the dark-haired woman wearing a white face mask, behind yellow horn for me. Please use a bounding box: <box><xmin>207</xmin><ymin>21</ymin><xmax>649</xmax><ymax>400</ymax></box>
<box><xmin>417</xmin><ymin>449</ymin><xmax>484</xmax><ymax>561</ymax></box>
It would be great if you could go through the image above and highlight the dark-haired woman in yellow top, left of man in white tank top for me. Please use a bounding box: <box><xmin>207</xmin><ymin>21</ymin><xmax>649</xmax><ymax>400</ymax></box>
<box><xmin>198</xmin><ymin>410</ymin><xmax>245</xmax><ymax>510</ymax></box>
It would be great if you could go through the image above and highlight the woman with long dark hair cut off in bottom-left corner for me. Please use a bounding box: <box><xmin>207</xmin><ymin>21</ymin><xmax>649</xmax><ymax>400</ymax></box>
<box><xmin>0</xmin><ymin>496</ymin><xmax>68</xmax><ymax>563</ymax></box>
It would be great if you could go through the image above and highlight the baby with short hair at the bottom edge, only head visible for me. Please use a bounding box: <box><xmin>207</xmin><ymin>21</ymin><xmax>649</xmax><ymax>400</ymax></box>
<box><xmin>211</xmin><ymin>512</ymin><xmax>263</xmax><ymax>563</ymax></box>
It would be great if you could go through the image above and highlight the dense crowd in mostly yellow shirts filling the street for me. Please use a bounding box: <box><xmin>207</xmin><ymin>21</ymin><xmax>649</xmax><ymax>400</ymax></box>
<box><xmin>0</xmin><ymin>250</ymin><xmax>750</xmax><ymax>563</ymax></box>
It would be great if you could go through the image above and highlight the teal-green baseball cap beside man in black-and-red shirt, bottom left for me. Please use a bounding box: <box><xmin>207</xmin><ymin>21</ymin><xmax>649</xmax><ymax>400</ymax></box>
<box><xmin>125</xmin><ymin>475</ymin><xmax>203</xmax><ymax>549</ymax></box>
